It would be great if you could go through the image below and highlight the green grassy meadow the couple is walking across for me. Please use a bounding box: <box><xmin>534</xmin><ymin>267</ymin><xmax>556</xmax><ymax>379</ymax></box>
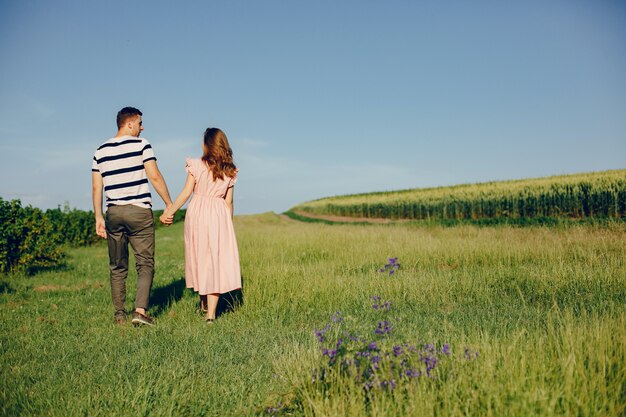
<box><xmin>0</xmin><ymin>214</ymin><xmax>626</xmax><ymax>416</ymax></box>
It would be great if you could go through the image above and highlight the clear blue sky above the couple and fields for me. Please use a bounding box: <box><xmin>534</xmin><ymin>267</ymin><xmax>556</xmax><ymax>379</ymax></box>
<box><xmin>0</xmin><ymin>0</ymin><xmax>626</xmax><ymax>214</ymax></box>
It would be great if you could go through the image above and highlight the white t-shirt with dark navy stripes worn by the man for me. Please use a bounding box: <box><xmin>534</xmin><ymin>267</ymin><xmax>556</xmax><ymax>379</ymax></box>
<box><xmin>91</xmin><ymin>136</ymin><xmax>156</xmax><ymax>208</ymax></box>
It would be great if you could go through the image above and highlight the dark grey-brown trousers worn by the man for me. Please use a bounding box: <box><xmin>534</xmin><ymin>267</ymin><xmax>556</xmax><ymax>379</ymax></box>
<box><xmin>106</xmin><ymin>205</ymin><xmax>154</xmax><ymax>315</ymax></box>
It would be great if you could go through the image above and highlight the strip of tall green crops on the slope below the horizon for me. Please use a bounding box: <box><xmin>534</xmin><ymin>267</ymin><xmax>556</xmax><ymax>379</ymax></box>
<box><xmin>291</xmin><ymin>170</ymin><xmax>626</xmax><ymax>220</ymax></box>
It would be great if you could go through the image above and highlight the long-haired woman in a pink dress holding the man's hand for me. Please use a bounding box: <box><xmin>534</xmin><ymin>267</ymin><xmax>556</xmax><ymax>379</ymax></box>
<box><xmin>160</xmin><ymin>128</ymin><xmax>241</xmax><ymax>323</ymax></box>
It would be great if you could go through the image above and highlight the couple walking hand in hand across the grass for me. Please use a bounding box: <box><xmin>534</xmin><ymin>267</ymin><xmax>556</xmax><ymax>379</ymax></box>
<box><xmin>91</xmin><ymin>107</ymin><xmax>241</xmax><ymax>325</ymax></box>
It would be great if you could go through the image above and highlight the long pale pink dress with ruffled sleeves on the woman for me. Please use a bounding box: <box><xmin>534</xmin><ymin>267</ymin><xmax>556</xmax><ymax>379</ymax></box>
<box><xmin>185</xmin><ymin>158</ymin><xmax>241</xmax><ymax>295</ymax></box>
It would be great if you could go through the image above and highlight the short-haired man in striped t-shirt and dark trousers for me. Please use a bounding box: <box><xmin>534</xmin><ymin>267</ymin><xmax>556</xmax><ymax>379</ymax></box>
<box><xmin>91</xmin><ymin>107</ymin><xmax>172</xmax><ymax>325</ymax></box>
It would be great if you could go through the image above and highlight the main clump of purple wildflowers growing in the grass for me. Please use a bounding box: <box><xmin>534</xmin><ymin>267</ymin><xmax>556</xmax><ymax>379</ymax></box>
<box><xmin>313</xmin><ymin>296</ymin><xmax>451</xmax><ymax>393</ymax></box>
